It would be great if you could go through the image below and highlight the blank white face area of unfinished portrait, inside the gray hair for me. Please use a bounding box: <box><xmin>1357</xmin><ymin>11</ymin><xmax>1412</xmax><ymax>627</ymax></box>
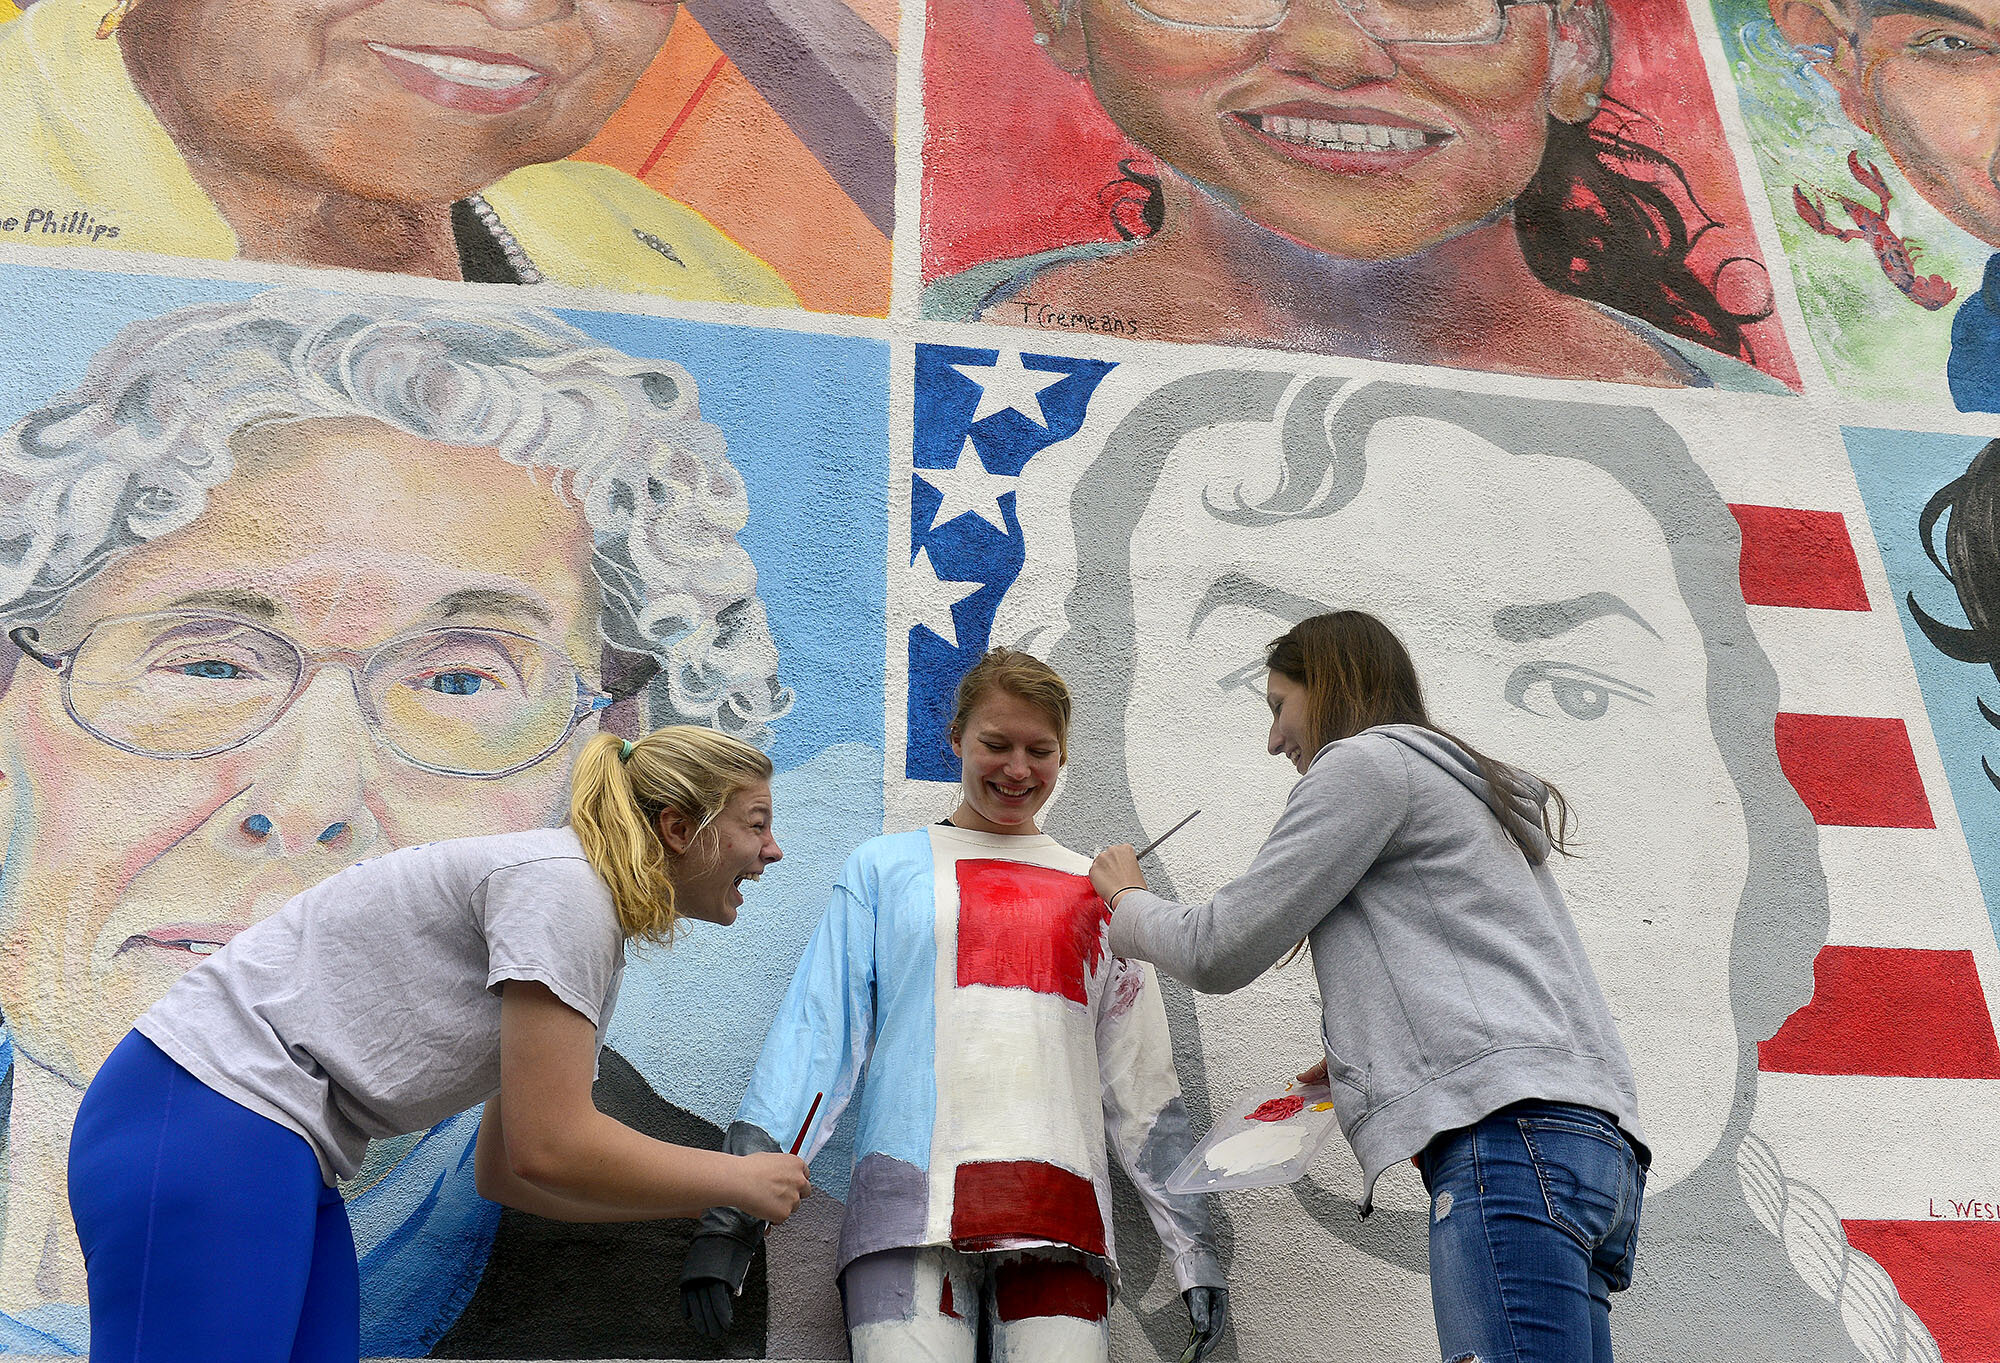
<box><xmin>1126</xmin><ymin>405</ymin><xmax>1748</xmax><ymax>1189</ymax></box>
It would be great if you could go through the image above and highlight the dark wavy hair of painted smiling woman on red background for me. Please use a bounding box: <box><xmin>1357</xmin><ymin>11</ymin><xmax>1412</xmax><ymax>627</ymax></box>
<box><xmin>1098</xmin><ymin>100</ymin><xmax>1770</xmax><ymax>362</ymax></box>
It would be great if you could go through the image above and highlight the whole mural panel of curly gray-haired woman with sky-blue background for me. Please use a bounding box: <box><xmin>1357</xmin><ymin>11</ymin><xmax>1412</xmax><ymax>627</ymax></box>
<box><xmin>0</xmin><ymin>274</ymin><xmax>886</xmax><ymax>1357</ymax></box>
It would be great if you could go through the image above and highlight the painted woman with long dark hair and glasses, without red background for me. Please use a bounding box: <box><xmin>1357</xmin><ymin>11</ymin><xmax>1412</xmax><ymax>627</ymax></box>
<box><xmin>924</xmin><ymin>0</ymin><xmax>1776</xmax><ymax>390</ymax></box>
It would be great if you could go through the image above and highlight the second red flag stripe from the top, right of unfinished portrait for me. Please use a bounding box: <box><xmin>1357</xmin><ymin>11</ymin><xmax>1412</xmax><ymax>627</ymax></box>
<box><xmin>1776</xmin><ymin>713</ymin><xmax>1936</xmax><ymax>827</ymax></box>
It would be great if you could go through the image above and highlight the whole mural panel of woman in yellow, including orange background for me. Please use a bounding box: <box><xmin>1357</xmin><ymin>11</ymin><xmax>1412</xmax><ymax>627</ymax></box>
<box><xmin>0</xmin><ymin>0</ymin><xmax>896</xmax><ymax>314</ymax></box>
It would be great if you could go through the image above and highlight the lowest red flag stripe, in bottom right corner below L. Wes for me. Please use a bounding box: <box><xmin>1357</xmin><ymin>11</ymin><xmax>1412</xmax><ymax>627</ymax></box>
<box><xmin>1840</xmin><ymin>1215</ymin><xmax>2000</xmax><ymax>1363</ymax></box>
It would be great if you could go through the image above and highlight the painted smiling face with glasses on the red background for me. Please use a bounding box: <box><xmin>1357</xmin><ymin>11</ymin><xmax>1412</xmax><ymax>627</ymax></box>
<box><xmin>1048</xmin><ymin>0</ymin><xmax>1610</xmax><ymax>260</ymax></box>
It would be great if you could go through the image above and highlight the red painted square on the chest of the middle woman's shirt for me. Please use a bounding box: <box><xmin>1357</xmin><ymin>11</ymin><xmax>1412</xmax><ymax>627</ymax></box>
<box><xmin>958</xmin><ymin>859</ymin><xmax>1110</xmax><ymax>1003</ymax></box>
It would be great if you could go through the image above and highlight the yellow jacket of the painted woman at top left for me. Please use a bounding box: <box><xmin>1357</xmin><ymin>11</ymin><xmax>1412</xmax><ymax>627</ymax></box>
<box><xmin>0</xmin><ymin>0</ymin><xmax>796</xmax><ymax>306</ymax></box>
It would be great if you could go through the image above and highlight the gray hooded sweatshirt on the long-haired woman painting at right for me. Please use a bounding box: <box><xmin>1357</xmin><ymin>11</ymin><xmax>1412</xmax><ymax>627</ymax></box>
<box><xmin>1110</xmin><ymin>723</ymin><xmax>1646</xmax><ymax>1213</ymax></box>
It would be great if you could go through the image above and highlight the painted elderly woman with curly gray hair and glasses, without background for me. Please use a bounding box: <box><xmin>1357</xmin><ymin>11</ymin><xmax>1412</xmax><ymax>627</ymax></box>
<box><xmin>0</xmin><ymin>292</ymin><xmax>790</xmax><ymax>1357</ymax></box>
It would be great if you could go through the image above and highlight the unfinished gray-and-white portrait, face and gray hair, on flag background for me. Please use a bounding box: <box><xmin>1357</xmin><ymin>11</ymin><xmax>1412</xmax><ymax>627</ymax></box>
<box><xmin>1050</xmin><ymin>370</ymin><xmax>1826</xmax><ymax>1339</ymax></box>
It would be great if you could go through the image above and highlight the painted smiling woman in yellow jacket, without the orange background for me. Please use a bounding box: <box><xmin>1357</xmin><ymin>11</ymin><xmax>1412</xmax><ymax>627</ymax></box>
<box><xmin>0</xmin><ymin>0</ymin><xmax>794</xmax><ymax>297</ymax></box>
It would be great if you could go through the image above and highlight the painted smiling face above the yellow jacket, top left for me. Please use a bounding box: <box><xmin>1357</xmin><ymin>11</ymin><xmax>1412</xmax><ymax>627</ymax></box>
<box><xmin>118</xmin><ymin>0</ymin><xmax>678</xmax><ymax>204</ymax></box>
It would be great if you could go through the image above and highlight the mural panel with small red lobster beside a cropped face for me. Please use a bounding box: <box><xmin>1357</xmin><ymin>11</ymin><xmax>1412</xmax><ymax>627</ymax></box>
<box><xmin>1714</xmin><ymin>0</ymin><xmax>2000</xmax><ymax>412</ymax></box>
